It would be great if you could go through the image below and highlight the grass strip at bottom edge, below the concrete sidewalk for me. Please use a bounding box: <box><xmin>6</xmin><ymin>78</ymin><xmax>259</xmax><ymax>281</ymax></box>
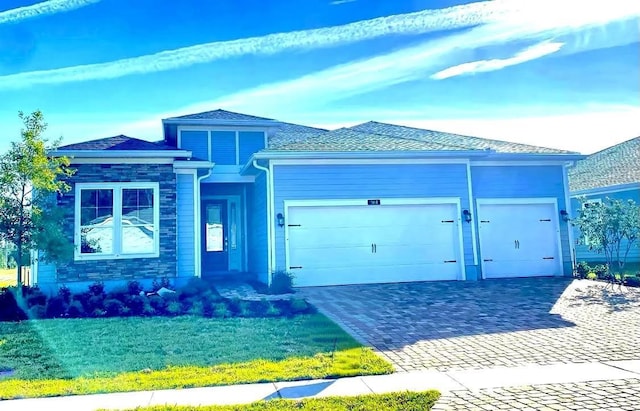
<box><xmin>109</xmin><ymin>391</ymin><xmax>440</xmax><ymax>411</ymax></box>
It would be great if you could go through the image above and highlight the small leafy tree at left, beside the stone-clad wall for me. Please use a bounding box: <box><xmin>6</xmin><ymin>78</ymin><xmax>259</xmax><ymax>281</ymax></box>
<box><xmin>0</xmin><ymin>111</ymin><xmax>73</xmax><ymax>284</ymax></box>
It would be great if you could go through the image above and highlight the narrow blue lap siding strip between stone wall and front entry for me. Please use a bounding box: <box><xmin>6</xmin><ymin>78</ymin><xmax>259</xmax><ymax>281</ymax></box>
<box><xmin>177</xmin><ymin>174</ymin><xmax>196</xmax><ymax>277</ymax></box>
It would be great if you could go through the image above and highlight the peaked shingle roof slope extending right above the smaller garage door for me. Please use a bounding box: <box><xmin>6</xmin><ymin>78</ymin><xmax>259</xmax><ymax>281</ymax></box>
<box><xmin>351</xmin><ymin>121</ymin><xmax>573</xmax><ymax>154</ymax></box>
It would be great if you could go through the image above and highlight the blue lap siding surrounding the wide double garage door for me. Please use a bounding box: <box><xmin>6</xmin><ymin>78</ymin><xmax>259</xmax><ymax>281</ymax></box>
<box><xmin>273</xmin><ymin>164</ymin><xmax>473</xmax><ymax>269</ymax></box>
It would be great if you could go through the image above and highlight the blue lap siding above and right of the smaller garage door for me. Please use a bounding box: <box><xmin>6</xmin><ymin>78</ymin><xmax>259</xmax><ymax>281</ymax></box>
<box><xmin>471</xmin><ymin>166</ymin><xmax>571</xmax><ymax>274</ymax></box>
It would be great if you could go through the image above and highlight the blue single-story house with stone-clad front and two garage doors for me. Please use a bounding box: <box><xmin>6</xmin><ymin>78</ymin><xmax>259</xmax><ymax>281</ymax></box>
<box><xmin>33</xmin><ymin>110</ymin><xmax>584</xmax><ymax>290</ymax></box>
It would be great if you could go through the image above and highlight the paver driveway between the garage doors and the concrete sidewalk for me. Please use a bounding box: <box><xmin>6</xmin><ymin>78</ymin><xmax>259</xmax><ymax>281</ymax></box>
<box><xmin>300</xmin><ymin>278</ymin><xmax>640</xmax><ymax>371</ymax></box>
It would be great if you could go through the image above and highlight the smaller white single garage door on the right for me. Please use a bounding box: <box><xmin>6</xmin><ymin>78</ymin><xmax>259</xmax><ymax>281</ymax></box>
<box><xmin>478</xmin><ymin>200</ymin><xmax>562</xmax><ymax>278</ymax></box>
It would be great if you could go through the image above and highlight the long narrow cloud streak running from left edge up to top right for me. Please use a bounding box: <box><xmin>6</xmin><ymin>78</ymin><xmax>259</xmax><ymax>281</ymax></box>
<box><xmin>0</xmin><ymin>0</ymin><xmax>526</xmax><ymax>89</ymax></box>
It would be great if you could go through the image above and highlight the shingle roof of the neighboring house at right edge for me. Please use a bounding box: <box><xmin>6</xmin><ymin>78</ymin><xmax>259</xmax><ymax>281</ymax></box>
<box><xmin>569</xmin><ymin>137</ymin><xmax>640</xmax><ymax>191</ymax></box>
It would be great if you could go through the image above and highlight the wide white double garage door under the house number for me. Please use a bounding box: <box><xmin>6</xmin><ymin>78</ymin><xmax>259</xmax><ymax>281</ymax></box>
<box><xmin>287</xmin><ymin>204</ymin><xmax>462</xmax><ymax>286</ymax></box>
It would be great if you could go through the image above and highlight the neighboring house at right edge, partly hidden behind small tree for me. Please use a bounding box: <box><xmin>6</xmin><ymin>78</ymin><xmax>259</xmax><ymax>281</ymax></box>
<box><xmin>569</xmin><ymin>137</ymin><xmax>640</xmax><ymax>263</ymax></box>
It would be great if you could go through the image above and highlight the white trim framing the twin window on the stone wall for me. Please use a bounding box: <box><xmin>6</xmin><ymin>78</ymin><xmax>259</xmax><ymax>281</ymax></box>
<box><xmin>73</xmin><ymin>182</ymin><xmax>160</xmax><ymax>261</ymax></box>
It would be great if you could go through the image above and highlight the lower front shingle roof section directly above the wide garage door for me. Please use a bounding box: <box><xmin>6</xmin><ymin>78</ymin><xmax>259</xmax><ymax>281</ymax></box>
<box><xmin>269</xmin><ymin>128</ymin><xmax>466</xmax><ymax>152</ymax></box>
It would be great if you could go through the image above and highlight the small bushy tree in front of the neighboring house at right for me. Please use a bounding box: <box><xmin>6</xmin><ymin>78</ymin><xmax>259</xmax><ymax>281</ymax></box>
<box><xmin>573</xmin><ymin>198</ymin><xmax>640</xmax><ymax>273</ymax></box>
